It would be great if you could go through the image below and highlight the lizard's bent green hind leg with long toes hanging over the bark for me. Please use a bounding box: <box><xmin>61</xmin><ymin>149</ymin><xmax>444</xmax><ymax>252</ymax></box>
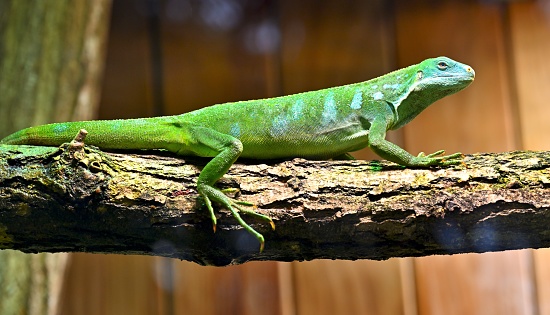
<box><xmin>188</xmin><ymin>127</ymin><xmax>275</xmax><ymax>252</ymax></box>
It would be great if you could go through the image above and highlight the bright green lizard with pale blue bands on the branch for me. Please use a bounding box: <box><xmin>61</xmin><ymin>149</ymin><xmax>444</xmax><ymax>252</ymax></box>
<box><xmin>0</xmin><ymin>57</ymin><xmax>475</xmax><ymax>251</ymax></box>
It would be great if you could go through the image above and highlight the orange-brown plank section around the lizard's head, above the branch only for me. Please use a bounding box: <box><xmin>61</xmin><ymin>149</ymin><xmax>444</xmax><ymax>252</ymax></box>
<box><xmin>396</xmin><ymin>0</ymin><xmax>517</xmax><ymax>153</ymax></box>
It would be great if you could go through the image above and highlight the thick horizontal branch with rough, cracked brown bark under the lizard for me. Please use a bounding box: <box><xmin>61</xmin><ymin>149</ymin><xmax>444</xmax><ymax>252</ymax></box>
<box><xmin>0</xmin><ymin>145</ymin><xmax>550</xmax><ymax>266</ymax></box>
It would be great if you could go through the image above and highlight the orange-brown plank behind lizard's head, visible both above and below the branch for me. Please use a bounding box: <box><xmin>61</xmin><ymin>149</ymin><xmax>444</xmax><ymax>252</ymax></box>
<box><xmin>397</xmin><ymin>1</ymin><xmax>534</xmax><ymax>314</ymax></box>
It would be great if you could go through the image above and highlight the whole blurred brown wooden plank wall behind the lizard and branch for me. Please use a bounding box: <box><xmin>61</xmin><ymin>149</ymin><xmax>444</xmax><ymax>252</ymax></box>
<box><xmin>62</xmin><ymin>0</ymin><xmax>550</xmax><ymax>315</ymax></box>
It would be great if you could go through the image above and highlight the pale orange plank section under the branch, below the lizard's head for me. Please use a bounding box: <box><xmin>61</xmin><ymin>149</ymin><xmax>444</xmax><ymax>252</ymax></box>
<box><xmin>416</xmin><ymin>251</ymin><xmax>535</xmax><ymax>315</ymax></box>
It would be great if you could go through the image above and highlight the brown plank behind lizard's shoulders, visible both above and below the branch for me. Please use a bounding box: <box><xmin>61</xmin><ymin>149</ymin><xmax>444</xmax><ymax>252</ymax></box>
<box><xmin>280</xmin><ymin>0</ymin><xmax>410</xmax><ymax>314</ymax></box>
